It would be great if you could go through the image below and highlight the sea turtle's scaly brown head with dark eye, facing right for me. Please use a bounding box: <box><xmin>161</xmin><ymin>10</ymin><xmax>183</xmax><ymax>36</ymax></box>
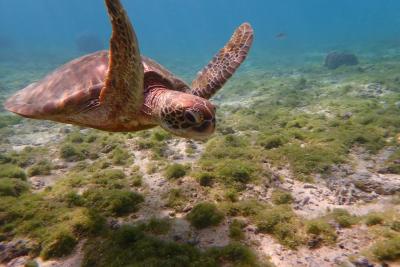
<box><xmin>159</xmin><ymin>93</ymin><xmax>216</xmax><ymax>139</ymax></box>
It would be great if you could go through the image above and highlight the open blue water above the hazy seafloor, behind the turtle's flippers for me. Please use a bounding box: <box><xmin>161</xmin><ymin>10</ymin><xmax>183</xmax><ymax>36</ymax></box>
<box><xmin>0</xmin><ymin>0</ymin><xmax>400</xmax><ymax>68</ymax></box>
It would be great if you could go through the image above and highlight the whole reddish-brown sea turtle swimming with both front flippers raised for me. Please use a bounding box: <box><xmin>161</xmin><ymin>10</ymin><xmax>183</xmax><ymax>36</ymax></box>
<box><xmin>5</xmin><ymin>0</ymin><xmax>253</xmax><ymax>139</ymax></box>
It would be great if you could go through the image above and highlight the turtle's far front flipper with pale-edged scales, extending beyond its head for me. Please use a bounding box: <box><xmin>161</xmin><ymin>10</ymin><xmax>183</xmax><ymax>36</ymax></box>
<box><xmin>189</xmin><ymin>23</ymin><xmax>254</xmax><ymax>99</ymax></box>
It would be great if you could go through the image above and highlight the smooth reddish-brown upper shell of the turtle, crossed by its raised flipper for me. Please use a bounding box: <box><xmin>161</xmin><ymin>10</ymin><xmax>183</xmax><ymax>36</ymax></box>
<box><xmin>4</xmin><ymin>51</ymin><xmax>189</xmax><ymax>119</ymax></box>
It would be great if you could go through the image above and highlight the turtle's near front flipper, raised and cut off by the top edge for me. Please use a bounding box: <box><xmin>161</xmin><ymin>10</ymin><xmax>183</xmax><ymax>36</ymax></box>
<box><xmin>100</xmin><ymin>0</ymin><xmax>144</xmax><ymax>114</ymax></box>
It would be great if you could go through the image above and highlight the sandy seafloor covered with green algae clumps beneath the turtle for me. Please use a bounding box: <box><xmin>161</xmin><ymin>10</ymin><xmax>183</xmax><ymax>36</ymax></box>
<box><xmin>0</xmin><ymin>49</ymin><xmax>400</xmax><ymax>266</ymax></box>
